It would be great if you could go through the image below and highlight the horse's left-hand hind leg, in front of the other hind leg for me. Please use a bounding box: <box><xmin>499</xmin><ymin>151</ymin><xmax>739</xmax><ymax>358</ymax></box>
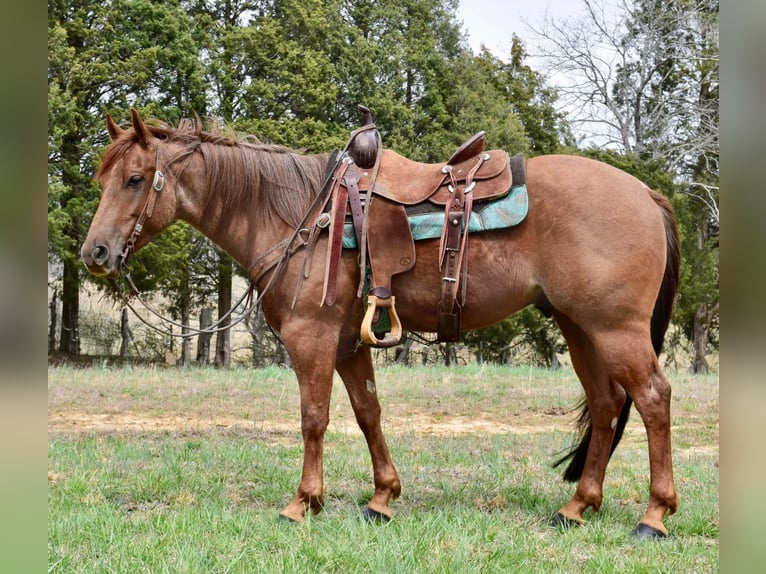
<box><xmin>555</xmin><ymin>313</ymin><xmax>626</xmax><ymax>524</ymax></box>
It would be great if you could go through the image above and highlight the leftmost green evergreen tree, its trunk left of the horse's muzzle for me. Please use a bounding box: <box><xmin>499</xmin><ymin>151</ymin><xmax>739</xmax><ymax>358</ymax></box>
<box><xmin>48</xmin><ymin>0</ymin><xmax>206</xmax><ymax>354</ymax></box>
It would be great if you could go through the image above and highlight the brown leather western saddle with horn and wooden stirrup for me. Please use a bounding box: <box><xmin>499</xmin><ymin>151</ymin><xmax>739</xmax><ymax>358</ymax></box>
<box><xmin>307</xmin><ymin>106</ymin><xmax>513</xmax><ymax>347</ymax></box>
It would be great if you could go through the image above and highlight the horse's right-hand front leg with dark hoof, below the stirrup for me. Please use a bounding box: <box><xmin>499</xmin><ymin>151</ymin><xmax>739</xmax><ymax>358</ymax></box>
<box><xmin>336</xmin><ymin>347</ymin><xmax>402</xmax><ymax>520</ymax></box>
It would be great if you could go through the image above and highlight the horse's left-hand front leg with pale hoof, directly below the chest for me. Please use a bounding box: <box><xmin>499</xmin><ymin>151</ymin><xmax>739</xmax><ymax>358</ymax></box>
<box><xmin>279</xmin><ymin>326</ymin><xmax>335</xmax><ymax>522</ymax></box>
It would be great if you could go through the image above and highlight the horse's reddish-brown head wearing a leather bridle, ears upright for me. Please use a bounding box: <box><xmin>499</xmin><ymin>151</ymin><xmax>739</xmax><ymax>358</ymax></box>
<box><xmin>80</xmin><ymin>110</ymin><xmax>176</xmax><ymax>277</ymax></box>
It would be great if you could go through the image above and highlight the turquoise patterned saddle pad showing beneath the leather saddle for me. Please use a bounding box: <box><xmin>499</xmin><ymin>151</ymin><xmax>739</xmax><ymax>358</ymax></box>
<box><xmin>343</xmin><ymin>185</ymin><xmax>529</xmax><ymax>249</ymax></box>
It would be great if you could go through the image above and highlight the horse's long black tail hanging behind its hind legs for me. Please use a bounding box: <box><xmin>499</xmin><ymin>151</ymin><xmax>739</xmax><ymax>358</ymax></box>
<box><xmin>553</xmin><ymin>190</ymin><xmax>681</xmax><ymax>482</ymax></box>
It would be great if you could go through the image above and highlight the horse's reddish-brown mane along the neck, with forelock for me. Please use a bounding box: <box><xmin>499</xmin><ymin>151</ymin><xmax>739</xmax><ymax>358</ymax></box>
<box><xmin>97</xmin><ymin>118</ymin><xmax>328</xmax><ymax>235</ymax></box>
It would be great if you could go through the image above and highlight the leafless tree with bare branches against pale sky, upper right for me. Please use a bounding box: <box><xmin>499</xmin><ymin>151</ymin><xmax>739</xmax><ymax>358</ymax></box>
<box><xmin>527</xmin><ymin>0</ymin><xmax>719</xmax><ymax>221</ymax></box>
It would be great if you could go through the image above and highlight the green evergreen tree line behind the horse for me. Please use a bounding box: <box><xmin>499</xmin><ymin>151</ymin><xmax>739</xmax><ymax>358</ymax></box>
<box><xmin>48</xmin><ymin>0</ymin><xmax>718</xmax><ymax>371</ymax></box>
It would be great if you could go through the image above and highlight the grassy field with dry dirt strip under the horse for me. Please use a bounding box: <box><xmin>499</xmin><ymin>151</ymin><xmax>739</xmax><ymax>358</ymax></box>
<box><xmin>48</xmin><ymin>365</ymin><xmax>718</xmax><ymax>574</ymax></box>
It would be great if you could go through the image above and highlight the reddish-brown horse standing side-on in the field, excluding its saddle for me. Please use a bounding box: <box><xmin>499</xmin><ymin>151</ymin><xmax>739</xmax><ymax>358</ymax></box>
<box><xmin>81</xmin><ymin>110</ymin><xmax>680</xmax><ymax>539</ymax></box>
